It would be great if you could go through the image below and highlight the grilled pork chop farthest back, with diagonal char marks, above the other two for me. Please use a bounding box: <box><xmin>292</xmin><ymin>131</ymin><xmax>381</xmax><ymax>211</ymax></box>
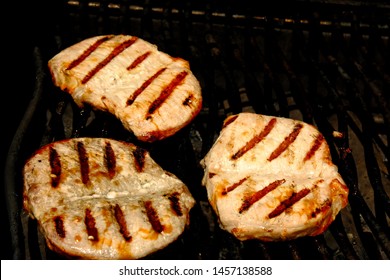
<box><xmin>48</xmin><ymin>35</ymin><xmax>202</xmax><ymax>142</ymax></box>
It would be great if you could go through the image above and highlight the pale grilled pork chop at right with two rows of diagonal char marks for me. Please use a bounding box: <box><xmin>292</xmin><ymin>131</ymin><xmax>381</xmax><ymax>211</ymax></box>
<box><xmin>201</xmin><ymin>113</ymin><xmax>348</xmax><ymax>241</ymax></box>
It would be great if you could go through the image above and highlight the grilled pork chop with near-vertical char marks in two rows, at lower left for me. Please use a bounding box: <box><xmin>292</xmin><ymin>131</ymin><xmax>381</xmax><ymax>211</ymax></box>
<box><xmin>23</xmin><ymin>138</ymin><xmax>195</xmax><ymax>259</ymax></box>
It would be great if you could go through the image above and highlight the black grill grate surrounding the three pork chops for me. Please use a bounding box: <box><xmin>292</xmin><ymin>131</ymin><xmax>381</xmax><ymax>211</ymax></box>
<box><xmin>5</xmin><ymin>0</ymin><xmax>390</xmax><ymax>259</ymax></box>
